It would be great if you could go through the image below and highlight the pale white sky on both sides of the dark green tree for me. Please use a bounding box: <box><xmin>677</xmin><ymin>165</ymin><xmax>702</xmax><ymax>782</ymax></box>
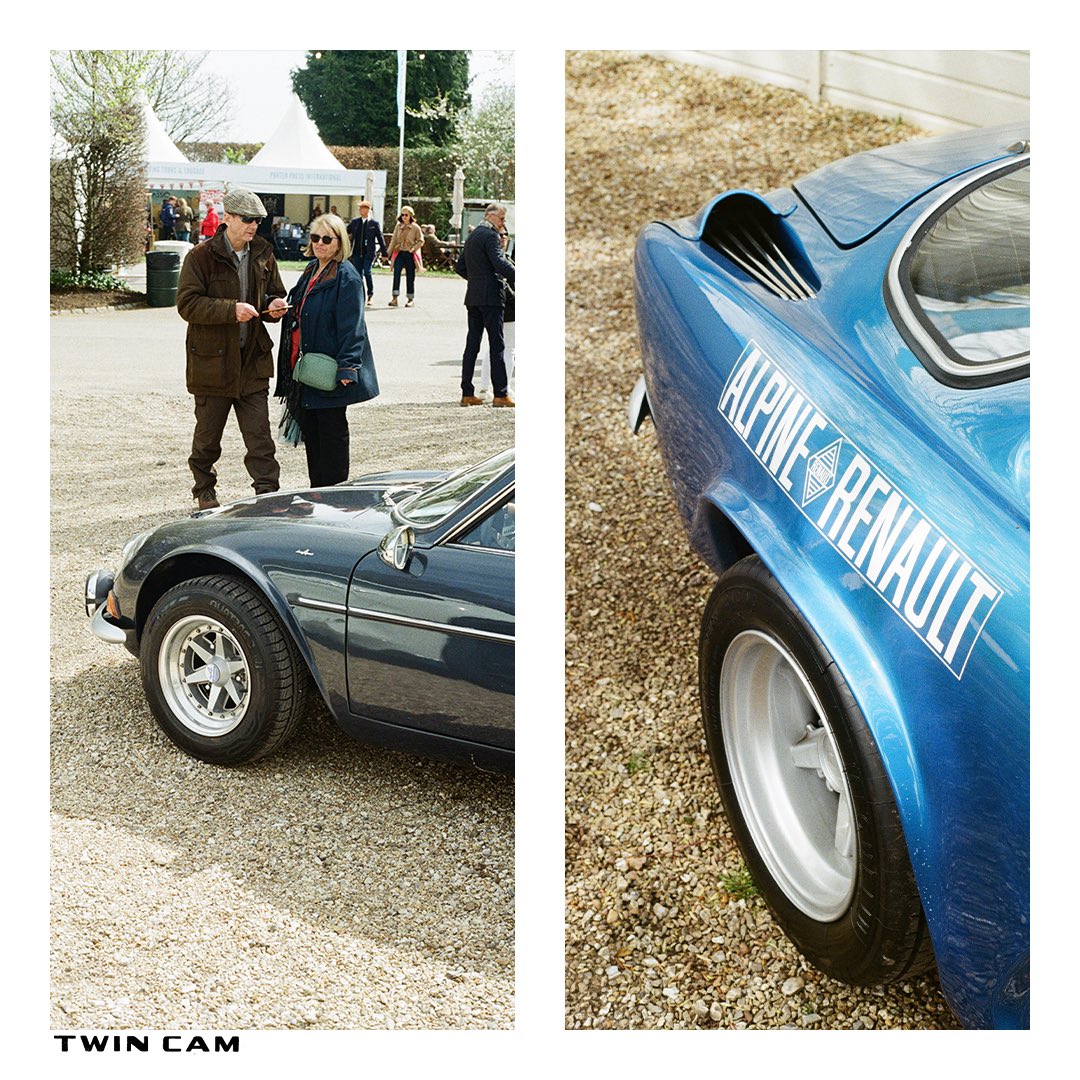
<box><xmin>186</xmin><ymin>50</ymin><xmax>514</xmax><ymax>143</ymax></box>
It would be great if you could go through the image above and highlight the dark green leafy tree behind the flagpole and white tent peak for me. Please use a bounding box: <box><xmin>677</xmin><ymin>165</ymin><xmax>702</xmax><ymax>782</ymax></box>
<box><xmin>293</xmin><ymin>49</ymin><xmax>469</xmax><ymax>147</ymax></box>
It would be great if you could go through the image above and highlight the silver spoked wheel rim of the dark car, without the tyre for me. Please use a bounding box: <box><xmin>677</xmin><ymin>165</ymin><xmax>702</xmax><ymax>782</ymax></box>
<box><xmin>158</xmin><ymin>615</ymin><xmax>251</xmax><ymax>738</ymax></box>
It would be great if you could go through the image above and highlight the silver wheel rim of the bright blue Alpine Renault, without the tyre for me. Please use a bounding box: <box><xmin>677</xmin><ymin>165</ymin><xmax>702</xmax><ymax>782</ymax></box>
<box><xmin>719</xmin><ymin>630</ymin><xmax>858</xmax><ymax>922</ymax></box>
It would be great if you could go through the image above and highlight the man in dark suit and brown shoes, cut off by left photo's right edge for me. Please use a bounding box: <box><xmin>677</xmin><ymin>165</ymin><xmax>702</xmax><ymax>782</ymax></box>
<box><xmin>455</xmin><ymin>203</ymin><xmax>514</xmax><ymax>408</ymax></box>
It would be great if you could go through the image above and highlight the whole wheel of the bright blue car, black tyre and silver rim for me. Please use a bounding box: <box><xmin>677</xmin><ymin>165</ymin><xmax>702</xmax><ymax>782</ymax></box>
<box><xmin>699</xmin><ymin>555</ymin><xmax>933</xmax><ymax>986</ymax></box>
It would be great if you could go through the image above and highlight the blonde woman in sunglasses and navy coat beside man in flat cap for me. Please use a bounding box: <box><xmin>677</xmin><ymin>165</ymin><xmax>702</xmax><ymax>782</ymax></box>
<box><xmin>274</xmin><ymin>214</ymin><xmax>379</xmax><ymax>487</ymax></box>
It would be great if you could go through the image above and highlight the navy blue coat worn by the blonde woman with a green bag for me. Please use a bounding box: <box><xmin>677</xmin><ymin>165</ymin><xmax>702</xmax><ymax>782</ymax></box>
<box><xmin>274</xmin><ymin>259</ymin><xmax>379</xmax><ymax>408</ymax></box>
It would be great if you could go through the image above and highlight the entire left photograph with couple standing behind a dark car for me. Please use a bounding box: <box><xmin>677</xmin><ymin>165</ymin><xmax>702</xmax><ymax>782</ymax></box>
<box><xmin>49</xmin><ymin>49</ymin><xmax>516</xmax><ymax>1032</ymax></box>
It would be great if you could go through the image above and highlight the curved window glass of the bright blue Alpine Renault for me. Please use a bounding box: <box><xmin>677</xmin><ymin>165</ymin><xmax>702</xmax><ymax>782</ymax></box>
<box><xmin>905</xmin><ymin>166</ymin><xmax>1031</xmax><ymax>374</ymax></box>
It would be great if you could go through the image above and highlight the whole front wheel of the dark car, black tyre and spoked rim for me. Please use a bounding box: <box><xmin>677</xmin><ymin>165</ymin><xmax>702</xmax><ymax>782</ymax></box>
<box><xmin>139</xmin><ymin>576</ymin><xmax>310</xmax><ymax>765</ymax></box>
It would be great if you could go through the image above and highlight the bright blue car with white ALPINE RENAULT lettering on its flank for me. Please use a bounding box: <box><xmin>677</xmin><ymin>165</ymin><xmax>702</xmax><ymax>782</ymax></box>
<box><xmin>630</xmin><ymin>127</ymin><xmax>1030</xmax><ymax>1027</ymax></box>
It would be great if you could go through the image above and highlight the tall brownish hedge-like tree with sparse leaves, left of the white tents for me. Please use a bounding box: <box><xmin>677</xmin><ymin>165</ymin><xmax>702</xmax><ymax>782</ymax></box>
<box><xmin>50</xmin><ymin>50</ymin><xmax>146</xmax><ymax>273</ymax></box>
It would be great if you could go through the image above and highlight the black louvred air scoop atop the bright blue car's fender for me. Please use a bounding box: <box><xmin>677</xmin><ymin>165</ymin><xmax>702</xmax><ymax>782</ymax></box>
<box><xmin>703</xmin><ymin>195</ymin><xmax>820</xmax><ymax>300</ymax></box>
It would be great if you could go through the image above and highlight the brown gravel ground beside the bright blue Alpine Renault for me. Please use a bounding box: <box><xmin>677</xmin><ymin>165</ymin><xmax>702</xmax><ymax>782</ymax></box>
<box><xmin>566</xmin><ymin>53</ymin><xmax>956</xmax><ymax>1028</ymax></box>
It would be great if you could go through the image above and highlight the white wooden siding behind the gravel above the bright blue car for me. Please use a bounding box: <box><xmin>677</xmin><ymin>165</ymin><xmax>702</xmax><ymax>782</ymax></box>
<box><xmin>653</xmin><ymin>50</ymin><xmax>1030</xmax><ymax>132</ymax></box>
